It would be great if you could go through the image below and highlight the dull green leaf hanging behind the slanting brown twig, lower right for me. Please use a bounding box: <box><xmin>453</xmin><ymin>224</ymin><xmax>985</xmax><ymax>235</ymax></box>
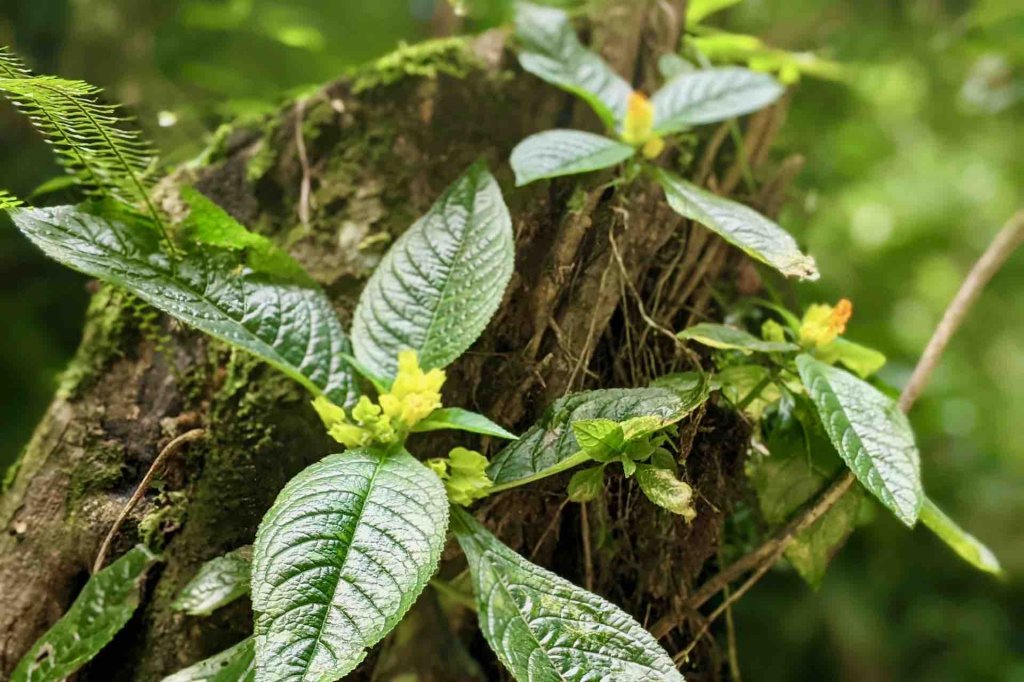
<box><xmin>748</xmin><ymin>394</ymin><xmax>864</xmax><ymax>588</ymax></box>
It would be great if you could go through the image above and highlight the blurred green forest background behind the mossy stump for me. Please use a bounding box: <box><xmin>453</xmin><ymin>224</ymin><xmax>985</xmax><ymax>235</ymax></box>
<box><xmin>0</xmin><ymin>0</ymin><xmax>1024</xmax><ymax>681</ymax></box>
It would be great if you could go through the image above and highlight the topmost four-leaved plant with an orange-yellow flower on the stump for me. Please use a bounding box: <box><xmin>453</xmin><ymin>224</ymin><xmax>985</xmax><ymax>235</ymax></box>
<box><xmin>509</xmin><ymin>3</ymin><xmax>818</xmax><ymax>280</ymax></box>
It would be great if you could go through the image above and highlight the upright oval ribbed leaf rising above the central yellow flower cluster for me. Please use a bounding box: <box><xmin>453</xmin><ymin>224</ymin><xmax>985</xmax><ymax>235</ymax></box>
<box><xmin>352</xmin><ymin>163</ymin><xmax>514</xmax><ymax>377</ymax></box>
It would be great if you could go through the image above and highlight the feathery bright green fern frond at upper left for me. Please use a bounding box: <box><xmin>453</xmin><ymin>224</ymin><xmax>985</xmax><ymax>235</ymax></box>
<box><xmin>0</xmin><ymin>47</ymin><xmax>163</xmax><ymax>237</ymax></box>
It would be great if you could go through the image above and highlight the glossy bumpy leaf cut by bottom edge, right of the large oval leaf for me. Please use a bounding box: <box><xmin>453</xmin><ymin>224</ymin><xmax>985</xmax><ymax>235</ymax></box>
<box><xmin>452</xmin><ymin>509</ymin><xmax>683</xmax><ymax>682</ymax></box>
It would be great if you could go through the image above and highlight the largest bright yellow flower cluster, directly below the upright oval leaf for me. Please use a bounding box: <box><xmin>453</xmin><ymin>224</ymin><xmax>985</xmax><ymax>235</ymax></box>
<box><xmin>313</xmin><ymin>350</ymin><xmax>444</xmax><ymax>447</ymax></box>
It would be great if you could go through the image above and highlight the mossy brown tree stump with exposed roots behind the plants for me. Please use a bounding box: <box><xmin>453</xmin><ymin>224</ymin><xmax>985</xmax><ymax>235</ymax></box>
<box><xmin>0</xmin><ymin>0</ymin><xmax>795</xmax><ymax>681</ymax></box>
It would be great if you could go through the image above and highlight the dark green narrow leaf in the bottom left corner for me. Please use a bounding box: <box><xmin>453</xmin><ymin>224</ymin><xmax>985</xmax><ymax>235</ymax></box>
<box><xmin>10</xmin><ymin>545</ymin><xmax>160</xmax><ymax>682</ymax></box>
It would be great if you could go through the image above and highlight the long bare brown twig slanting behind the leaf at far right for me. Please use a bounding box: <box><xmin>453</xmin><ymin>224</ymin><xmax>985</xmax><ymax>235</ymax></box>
<box><xmin>679</xmin><ymin>210</ymin><xmax>1024</xmax><ymax>618</ymax></box>
